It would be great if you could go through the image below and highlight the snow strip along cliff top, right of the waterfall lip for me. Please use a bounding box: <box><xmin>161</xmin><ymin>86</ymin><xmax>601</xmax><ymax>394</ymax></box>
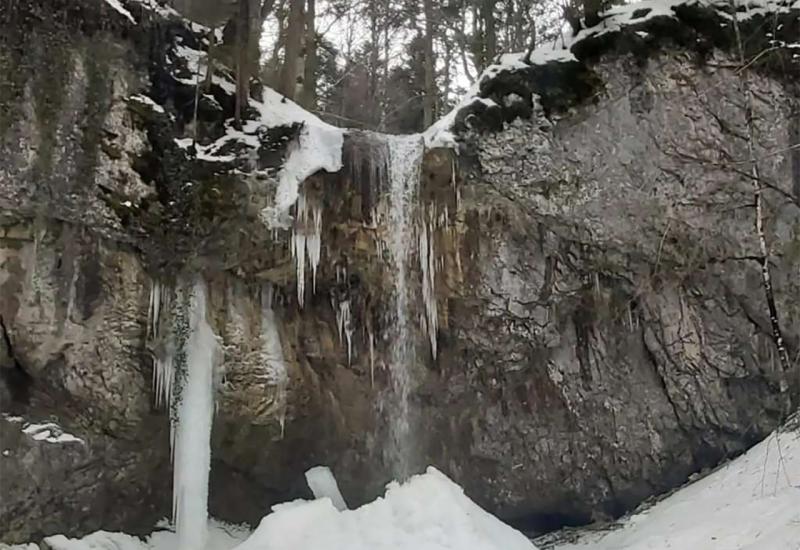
<box><xmin>424</xmin><ymin>0</ymin><xmax>800</xmax><ymax>148</ymax></box>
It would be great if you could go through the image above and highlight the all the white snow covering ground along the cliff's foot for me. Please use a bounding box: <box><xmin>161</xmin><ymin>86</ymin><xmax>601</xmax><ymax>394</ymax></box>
<box><xmin>15</xmin><ymin>432</ymin><xmax>800</xmax><ymax>550</ymax></box>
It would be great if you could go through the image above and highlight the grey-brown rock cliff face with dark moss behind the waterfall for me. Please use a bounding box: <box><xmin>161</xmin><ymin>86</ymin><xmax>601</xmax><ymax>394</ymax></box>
<box><xmin>0</xmin><ymin>0</ymin><xmax>800</xmax><ymax>542</ymax></box>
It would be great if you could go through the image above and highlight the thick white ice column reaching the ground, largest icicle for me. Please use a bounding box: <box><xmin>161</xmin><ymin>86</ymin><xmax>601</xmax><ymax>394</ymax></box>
<box><xmin>172</xmin><ymin>279</ymin><xmax>220</xmax><ymax>550</ymax></box>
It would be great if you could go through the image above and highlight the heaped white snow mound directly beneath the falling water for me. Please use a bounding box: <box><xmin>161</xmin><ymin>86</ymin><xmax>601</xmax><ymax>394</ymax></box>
<box><xmin>236</xmin><ymin>467</ymin><xmax>535</xmax><ymax>550</ymax></box>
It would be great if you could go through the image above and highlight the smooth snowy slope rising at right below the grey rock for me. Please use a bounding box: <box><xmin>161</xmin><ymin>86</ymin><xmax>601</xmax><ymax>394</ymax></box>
<box><xmin>554</xmin><ymin>432</ymin><xmax>800</xmax><ymax>550</ymax></box>
